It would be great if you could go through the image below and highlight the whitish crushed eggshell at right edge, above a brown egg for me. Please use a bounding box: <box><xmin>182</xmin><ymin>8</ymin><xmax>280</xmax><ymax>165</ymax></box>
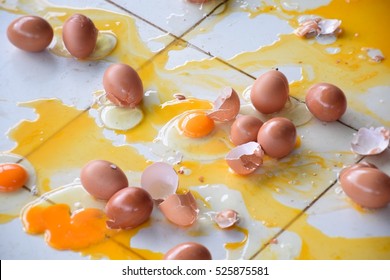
<box><xmin>351</xmin><ymin>127</ymin><xmax>390</xmax><ymax>155</ymax></box>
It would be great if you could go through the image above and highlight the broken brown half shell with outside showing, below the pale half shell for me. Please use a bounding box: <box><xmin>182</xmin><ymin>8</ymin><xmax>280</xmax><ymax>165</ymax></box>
<box><xmin>159</xmin><ymin>192</ymin><xmax>199</xmax><ymax>227</ymax></box>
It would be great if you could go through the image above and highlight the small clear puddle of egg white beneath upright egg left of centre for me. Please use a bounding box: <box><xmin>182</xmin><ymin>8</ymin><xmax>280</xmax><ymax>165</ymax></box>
<box><xmin>100</xmin><ymin>105</ymin><xmax>144</xmax><ymax>131</ymax></box>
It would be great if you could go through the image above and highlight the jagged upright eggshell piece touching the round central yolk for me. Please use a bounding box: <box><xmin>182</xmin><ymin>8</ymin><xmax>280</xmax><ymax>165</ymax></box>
<box><xmin>209</xmin><ymin>87</ymin><xmax>240</xmax><ymax>122</ymax></box>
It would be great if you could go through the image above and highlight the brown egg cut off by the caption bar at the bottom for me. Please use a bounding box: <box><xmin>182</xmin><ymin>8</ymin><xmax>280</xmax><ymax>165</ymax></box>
<box><xmin>164</xmin><ymin>242</ymin><xmax>212</xmax><ymax>260</ymax></box>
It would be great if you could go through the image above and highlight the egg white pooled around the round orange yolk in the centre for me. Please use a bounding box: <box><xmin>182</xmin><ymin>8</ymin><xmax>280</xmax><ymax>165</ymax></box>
<box><xmin>155</xmin><ymin>110</ymin><xmax>233</xmax><ymax>161</ymax></box>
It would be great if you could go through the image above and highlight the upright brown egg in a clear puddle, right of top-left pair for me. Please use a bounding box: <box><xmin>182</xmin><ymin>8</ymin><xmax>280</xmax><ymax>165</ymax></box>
<box><xmin>62</xmin><ymin>14</ymin><xmax>99</xmax><ymax>59</ymax></box>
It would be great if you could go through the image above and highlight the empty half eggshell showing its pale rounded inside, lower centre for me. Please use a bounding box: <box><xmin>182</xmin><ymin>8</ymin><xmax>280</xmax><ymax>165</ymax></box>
<box><xmin>141</xmin><ymin>162</ymin><xmax>179</xmax><ymax>200</ymax></box>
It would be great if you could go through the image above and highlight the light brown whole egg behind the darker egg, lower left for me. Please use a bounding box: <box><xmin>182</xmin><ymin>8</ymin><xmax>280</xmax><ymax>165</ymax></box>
<box><xmin>80</xmin><ymin>160</ymin><xmax>128</xmax><ymax>200</ymax></box>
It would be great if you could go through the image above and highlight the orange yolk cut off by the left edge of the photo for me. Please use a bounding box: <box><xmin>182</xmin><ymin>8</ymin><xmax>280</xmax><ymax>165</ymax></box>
<box><xmin>0</xmin><ymin>163</ymin><xmax>28</xmax><ymax>192</ymax></box>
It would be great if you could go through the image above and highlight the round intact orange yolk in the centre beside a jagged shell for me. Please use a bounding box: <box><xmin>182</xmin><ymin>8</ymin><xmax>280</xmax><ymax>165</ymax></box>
<box><xmin>179</xmin><ymin>112</ymin><xmax>215</xmax><ymax>138</ymax></box>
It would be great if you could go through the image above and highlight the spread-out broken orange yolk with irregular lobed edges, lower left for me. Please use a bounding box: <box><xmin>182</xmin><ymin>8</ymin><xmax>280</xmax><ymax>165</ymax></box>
<box><xmin>23</xmin><ymin>204</ymin><xmax>109</xmax><ymax>250</ymax></box>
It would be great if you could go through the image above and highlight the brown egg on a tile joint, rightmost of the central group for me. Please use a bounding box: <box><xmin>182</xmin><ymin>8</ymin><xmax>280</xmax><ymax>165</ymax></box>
<box><xmin>306</xmin><ymin>83</ymin><xmax>347</xmax><ymax>122</ymax></box>
